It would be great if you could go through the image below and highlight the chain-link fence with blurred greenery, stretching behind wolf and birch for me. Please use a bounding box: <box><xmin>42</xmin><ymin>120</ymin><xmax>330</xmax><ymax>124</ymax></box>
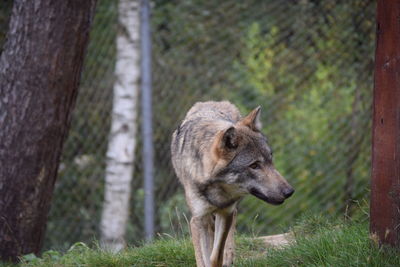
<box><xmin>3</xmin><ymin>0</ymin><xmax>375</xmax><ymax>251</ymax></box>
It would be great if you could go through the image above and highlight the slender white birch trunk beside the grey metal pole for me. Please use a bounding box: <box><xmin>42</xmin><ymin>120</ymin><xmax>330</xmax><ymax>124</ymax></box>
<box><xmin>101</xmin><ymin>0</ymin><xmax>140</xmax><ymax>251</ymax></box>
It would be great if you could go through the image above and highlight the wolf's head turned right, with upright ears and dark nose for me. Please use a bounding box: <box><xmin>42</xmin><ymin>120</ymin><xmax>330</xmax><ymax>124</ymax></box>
<box><xmin>213</xmin><ymin>107</ymin><xmax>294</xmax><ymax>205</ymax></box>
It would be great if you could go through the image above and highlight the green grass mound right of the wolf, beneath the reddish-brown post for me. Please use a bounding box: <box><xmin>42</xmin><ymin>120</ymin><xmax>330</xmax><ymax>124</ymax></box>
<box><xmin>234</xmin><ymin>216</ymin><xmax>400</xmax><ymax>267</ymax></box>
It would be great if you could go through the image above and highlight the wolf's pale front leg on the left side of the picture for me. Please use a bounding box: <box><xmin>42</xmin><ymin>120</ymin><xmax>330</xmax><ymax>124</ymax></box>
<box><xmin>190</xmin><ymin>214</ymin><xmax>214</xmax><ymax>267</ymax></box>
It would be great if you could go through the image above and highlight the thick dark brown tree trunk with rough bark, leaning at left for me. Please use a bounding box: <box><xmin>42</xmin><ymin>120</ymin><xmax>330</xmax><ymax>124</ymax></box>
<box><xmin>0</xmin><ymin>0</ymin><xmax>96</xmax><ymax>261</ymax></box>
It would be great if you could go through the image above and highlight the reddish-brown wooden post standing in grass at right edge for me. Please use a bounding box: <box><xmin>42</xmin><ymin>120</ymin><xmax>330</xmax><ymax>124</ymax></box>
<box><xmin>370</xmin><ymin>0</ymin><xmax>400</xmax><ymax>247</ymax></box>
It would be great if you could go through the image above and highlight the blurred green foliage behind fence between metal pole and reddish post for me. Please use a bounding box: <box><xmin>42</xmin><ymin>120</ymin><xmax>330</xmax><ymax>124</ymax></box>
<box><xmin>153</xmin><ymin>0</ymin><xmax>375</xmax><ymax>237</ymax></box>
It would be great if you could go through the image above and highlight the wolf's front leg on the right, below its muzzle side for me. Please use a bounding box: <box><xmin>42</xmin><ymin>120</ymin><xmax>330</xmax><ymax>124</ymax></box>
<box><xmin>211</xmin><ymin>212</ymin><xmax>234</xmax><ymax>267</ymax></box>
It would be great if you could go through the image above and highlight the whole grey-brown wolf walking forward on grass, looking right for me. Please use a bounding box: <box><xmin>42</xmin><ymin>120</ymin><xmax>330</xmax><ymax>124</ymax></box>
<box><xmin>171</xmin><ymin>101</ymin><xmax>294</xmax><ymax>267</ymax></box>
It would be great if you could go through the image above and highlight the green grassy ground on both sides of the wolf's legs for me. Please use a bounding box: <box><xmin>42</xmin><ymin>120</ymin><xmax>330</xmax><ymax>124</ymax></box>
<box><xmin>0</xmin><ymin>216</ymin><xmax>400</xmax><ymax>267</ymax></box>
